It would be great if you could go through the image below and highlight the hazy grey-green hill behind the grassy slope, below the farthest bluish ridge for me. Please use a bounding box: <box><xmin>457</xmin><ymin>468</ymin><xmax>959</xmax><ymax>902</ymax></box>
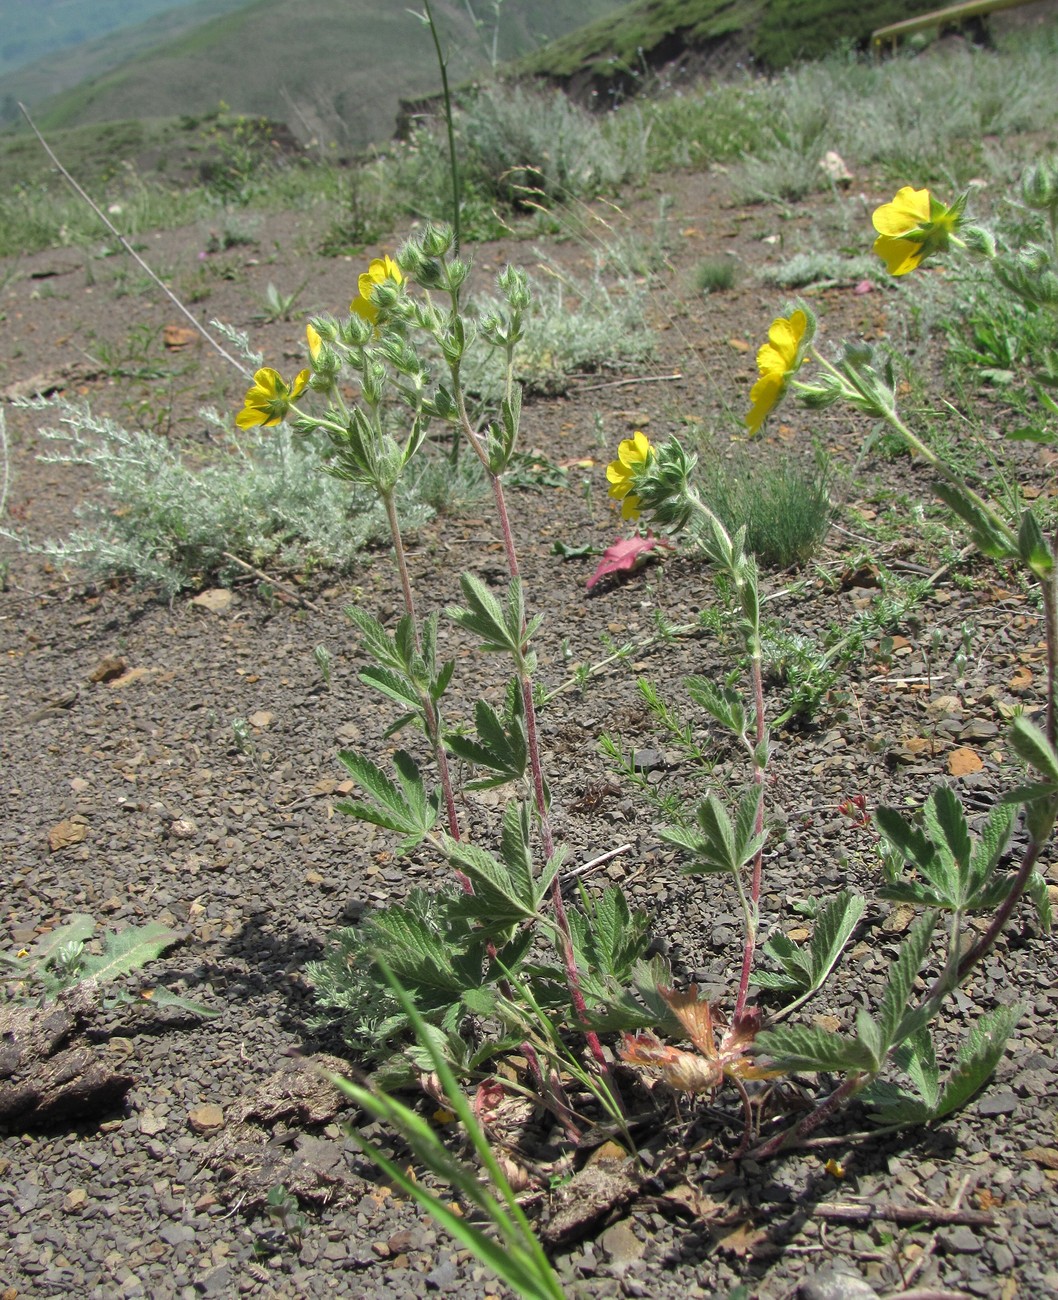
<box><xmin>0</xmin><ymin>0</ymin><xmax>629</xmax><ymax>148</ymax></box>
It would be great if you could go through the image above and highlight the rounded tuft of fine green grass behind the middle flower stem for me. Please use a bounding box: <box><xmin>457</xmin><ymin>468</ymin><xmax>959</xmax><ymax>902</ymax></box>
<box><xmin>702</xmin><ymin>458</ymin><xmax>833</xmax><ymax>569</ymax></box>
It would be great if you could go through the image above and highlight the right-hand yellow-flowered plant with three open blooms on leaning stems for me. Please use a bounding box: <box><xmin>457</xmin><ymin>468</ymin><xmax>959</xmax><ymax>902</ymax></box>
<box><xmin>608</xmin><ymin>163</ymin><xmax>1058</xmax><ymax>1157</ymax></box>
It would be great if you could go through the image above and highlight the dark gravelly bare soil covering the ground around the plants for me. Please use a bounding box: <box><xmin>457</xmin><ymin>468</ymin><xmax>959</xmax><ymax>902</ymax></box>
<box><xmin>0</xmin><ymin>147</ymin><xmax>1058</xmax><ymax>1300</ymax></box>
